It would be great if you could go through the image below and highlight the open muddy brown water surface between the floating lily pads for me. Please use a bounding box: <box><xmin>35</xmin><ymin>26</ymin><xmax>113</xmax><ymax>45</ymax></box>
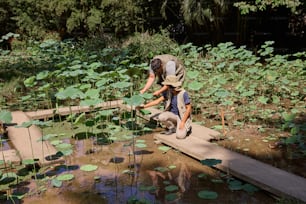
<box><xmin>23</xmin><ymin>134</ymin><xmax>275</xmax><ymax>204</ymax></box>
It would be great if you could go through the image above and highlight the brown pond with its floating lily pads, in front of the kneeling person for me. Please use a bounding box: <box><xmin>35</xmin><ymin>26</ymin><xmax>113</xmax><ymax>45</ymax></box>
<box><xmin>2</xmin><ymin>116</ymin><xmax>276</xmax><ymax>204</ymax></box>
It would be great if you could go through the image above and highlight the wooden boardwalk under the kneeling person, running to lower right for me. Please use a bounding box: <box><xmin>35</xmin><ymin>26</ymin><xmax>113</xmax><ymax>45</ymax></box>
<box><xmin>142</xmin><ymin>108</ymin><xmax>306</xmax><ymax>202</ymax></box>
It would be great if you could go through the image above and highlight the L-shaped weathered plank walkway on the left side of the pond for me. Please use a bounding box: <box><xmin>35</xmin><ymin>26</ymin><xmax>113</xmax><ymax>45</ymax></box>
<box><xmin>4</xmin><ymin>100</ymin><xmax>122</xmax><ymax>166</ymax></box>
